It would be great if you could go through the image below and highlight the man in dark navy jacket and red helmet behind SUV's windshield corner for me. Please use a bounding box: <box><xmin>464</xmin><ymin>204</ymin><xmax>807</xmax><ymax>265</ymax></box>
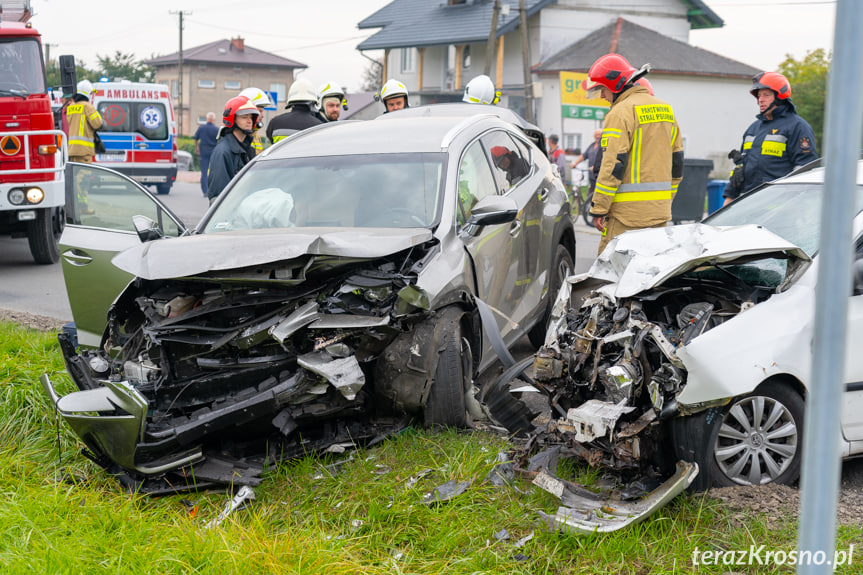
<box><xmin>207</xmin><ymin>96</ymin><xmax>259</xmax><ymax>204</ymax></box>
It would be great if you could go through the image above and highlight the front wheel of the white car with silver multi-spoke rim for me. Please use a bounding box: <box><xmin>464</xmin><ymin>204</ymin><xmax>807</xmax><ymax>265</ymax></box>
<box><xmin>674</xmin><ymin>381</ymin><xmax>804</xmax><ymax>491</ymax></box>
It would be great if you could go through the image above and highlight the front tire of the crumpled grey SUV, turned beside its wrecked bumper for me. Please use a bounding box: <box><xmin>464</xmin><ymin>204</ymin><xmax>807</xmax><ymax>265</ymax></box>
<box><xmin>423</xmin><ymin>321</ymin><xmax>473</xmax><ymax>428</ymax></box>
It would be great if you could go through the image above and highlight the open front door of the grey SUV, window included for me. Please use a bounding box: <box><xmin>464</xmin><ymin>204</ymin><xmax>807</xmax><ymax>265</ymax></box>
<box><xmin>60</xmin><ymin>162</ymin><xmax>185</xmax><ymax>346</ymax></box>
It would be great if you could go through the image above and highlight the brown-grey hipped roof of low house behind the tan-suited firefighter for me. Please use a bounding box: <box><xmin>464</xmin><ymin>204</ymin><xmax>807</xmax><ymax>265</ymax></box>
<box><xmin>533</xmin><ymin>18</ymin><xmax>761</xmax><ymax>79</ymax></box>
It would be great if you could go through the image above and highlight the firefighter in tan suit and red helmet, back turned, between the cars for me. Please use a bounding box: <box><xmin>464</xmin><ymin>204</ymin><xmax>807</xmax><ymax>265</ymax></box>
<box><xmin>587</xmin><ymin>54</ymin><xmax>683</xmax><ymax>253</ymax></box>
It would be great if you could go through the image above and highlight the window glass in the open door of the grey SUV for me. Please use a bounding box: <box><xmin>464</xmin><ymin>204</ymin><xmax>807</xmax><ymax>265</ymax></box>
<box><xmin>66</xmin><ymin>165</ymin><xmax>180</xmax><ymax>236</ymax></box>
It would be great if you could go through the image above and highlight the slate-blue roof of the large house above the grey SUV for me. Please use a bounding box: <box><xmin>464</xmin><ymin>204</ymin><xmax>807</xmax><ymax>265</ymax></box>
<box><xmin>357</xmin><ymin>0</ymin><xmax>556</xmax><ymax>50</ymax></box>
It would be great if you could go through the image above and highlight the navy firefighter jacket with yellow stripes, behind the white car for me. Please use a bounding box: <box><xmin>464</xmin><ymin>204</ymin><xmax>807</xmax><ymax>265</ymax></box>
<box><xmin>723</xmin><ymin>102</ymin><xmax>818</xmax><ymax>198</ymax></box>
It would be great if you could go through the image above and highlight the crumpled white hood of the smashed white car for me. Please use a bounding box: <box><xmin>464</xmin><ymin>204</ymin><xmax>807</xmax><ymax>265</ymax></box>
<box><xmin>573</xmin><ymin>224</ymin><xmax>810</xmax><ymax>298</ymax></box>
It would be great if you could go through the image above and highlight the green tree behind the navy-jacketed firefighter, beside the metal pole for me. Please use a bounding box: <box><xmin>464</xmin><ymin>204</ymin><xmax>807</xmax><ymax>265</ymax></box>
<box><xmin>779</xmin><ymin>48</ymin><xmax>831</xmax><ymax>155</ymax></box>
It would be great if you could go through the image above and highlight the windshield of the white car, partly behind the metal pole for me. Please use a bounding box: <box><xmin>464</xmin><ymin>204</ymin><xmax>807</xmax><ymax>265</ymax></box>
<box><xmin>704</xmin><ymin>183</ymin><xmax>863</xmax><ymax>257</ymax></box>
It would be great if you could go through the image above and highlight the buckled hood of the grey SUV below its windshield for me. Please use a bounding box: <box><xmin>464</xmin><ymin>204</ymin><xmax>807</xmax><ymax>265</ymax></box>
<box><xmin>111</xmin><ymin>228</ymin><xmax>432</xmax><ymax>280</ymax></box>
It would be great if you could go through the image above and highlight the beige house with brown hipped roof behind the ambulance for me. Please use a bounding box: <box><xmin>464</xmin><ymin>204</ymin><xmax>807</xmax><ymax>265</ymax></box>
<box><xmin>145</xmin><ymin>37</ymin><xmax>307</xmax><ymax>135</ymax></box>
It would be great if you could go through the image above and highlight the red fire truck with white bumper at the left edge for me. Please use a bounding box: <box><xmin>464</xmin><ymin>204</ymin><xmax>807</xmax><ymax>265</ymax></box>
<box><xmin>0</xmin><ymin>0</ymin><xmax>67</xmax><ymax>264</ymax></box>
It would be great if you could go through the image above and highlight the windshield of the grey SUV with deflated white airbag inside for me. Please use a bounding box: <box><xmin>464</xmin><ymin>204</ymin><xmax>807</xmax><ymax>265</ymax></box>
<box><xmin>203</xmin><ymin>153</ymin><xmax>444</xmax><ymax>233</ymax></box>
